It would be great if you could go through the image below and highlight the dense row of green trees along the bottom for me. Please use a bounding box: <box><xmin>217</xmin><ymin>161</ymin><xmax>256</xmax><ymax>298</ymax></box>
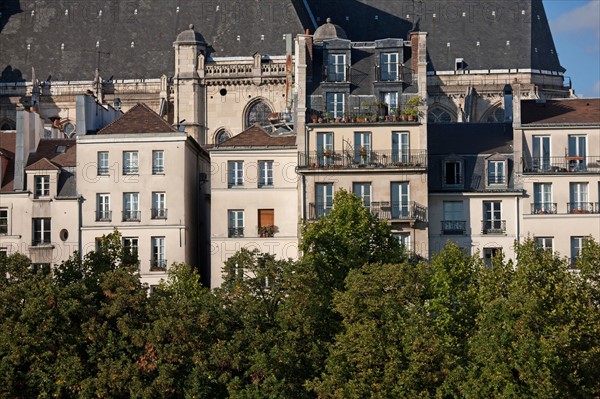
<box><xmin>0</xmin><ymin>192</ymin><xmax>600</xmax><ymax>398</ymax></box>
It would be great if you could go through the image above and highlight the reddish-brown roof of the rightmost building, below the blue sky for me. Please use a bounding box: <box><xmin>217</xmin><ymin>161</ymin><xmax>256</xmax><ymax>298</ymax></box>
<box><xmin>521</xmin><ymin>98</ymin><xmax>600</xmax><ymax>125</ymax></box>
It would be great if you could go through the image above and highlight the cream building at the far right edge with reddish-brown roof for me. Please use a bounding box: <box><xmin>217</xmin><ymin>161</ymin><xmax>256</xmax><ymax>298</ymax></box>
<box><xmin>515</xmin><ymin>98</ymin><xmax>600</xmax><ymax>265</ymax></box>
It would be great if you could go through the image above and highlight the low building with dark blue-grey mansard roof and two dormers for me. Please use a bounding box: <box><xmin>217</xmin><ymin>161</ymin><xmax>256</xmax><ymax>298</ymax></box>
<box><xmin>428</xmin><ymin>123</ymin><xmax>523</xmax><ymax>263</ymax></box>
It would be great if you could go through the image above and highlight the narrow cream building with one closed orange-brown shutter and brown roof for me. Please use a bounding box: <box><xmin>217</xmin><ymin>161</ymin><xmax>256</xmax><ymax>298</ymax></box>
<box><xmin>210</xmin><ymin>123</ymin><xmax>298</xmax><ymax>288</ymax></box>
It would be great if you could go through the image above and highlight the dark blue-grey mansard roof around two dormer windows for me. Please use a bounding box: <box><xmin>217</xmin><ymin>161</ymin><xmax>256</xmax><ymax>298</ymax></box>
<box><xmin>427</xmin><ymin>123</ymin><xmax>518</xmax><ymax>193</ymax></box>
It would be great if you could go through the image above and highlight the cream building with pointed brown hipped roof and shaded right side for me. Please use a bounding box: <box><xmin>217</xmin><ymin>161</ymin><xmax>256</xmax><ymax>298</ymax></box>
<box><xmin>77</xmin><ymin>104</ymin><xmax>210</xmax><ymax>286</ymax></box>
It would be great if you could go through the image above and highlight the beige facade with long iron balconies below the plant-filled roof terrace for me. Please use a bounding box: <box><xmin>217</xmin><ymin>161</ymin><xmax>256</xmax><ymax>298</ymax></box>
<box><xmin>298</xmin><ymin>122</ymin><xmax>428</xmax><ymax>257</ymax></box>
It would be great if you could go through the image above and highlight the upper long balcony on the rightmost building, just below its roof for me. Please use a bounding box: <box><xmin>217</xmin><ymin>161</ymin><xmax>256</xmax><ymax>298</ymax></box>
<box><xmin>523</xmin><ymin>155</ymin><xmax>600</xmax><ymax>174</ymax></box>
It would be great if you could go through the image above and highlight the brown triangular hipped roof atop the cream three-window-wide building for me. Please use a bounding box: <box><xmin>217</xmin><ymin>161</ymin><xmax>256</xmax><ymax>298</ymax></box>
<box><xmin>97</xmin><ymin>103</ymin><xmax>177</xmax><ymax>134</ymax></box>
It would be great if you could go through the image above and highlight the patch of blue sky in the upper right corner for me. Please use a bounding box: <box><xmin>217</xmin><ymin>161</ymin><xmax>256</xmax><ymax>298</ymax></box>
<box><xmin>543</xmin><ymin>0</ymin><xmax>600</xmax><ymax>97</ymax></box>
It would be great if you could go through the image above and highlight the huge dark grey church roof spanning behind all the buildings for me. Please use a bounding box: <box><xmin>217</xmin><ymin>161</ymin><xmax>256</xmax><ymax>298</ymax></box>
<box><xmin>0</xmin><ymin>0</ymin><xmax>563</xmax><ymax>82</ymax></box>
